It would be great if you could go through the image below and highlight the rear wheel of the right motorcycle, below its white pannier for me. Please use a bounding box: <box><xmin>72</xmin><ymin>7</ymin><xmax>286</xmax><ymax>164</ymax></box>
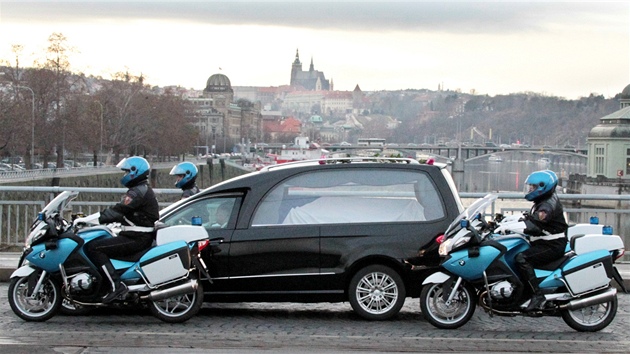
<box><xmin>562</xmin><ymin>295</ymin><xmax>617</xmax><ymax>332</ymax></box>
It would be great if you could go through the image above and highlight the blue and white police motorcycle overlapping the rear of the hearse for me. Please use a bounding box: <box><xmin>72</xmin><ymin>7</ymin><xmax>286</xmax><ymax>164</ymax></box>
<box><xmin>420</xmin><ymin>194</ymin><xmax>625</xmax><ymax>332</ymax></box>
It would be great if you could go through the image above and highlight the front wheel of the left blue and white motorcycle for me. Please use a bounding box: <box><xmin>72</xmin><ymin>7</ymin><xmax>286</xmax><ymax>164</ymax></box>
<box><xmin>9</xmin><ymin>277</ymin><xmax>61</xmax><ymax>322</ymax></box>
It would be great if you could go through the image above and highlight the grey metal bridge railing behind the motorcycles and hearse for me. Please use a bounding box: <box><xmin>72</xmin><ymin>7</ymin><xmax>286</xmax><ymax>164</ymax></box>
<box><xmin>0</xmin><ymin>186</ymin><xmax>630</xmax><ymax>256</ymax></box>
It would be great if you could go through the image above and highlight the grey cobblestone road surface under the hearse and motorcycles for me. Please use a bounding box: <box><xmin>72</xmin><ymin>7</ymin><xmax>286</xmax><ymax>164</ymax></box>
<box><xmin>0</xmin><ymin>283</ymin><xmax>630</xmax><ymax>354</ymax></box>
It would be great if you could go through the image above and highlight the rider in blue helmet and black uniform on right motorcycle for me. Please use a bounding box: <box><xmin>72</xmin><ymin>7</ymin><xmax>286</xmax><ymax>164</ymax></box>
<box><xmin>515</xmin><ymin>170</ymin><xmax>568</xmax><ymax>311</ymax></box>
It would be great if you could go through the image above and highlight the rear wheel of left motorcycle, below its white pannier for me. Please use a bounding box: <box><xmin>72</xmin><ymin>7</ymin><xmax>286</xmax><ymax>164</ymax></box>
<box><xmin>149</xmin><ymin>283</ymin><xmax>203</xmax><ymax>323</ymax></box>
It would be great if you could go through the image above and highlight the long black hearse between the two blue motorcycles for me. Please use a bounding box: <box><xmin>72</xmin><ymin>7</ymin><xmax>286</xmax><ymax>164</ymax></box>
<box><xmin>160</xmin><ymin>158</ymin><xmax>463</xmax><ymax>320</ymax></box>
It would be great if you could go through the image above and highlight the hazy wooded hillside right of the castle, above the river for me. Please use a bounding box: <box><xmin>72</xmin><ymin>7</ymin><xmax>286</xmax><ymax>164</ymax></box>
<box><xmin>363</xmin><ymin>90</ymin><xmax>619</xmax><ymax>146</ymax></box>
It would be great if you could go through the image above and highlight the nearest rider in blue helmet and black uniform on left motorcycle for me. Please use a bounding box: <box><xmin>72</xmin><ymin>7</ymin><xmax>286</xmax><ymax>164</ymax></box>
<box><xmin>85</xmin><ymin>156</ymin><xmax>159</xmax><ymax>303</ymax></box>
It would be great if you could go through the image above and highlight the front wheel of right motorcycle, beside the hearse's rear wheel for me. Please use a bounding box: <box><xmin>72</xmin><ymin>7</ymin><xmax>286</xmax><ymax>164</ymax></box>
<box><xmin>420</xmin><ymin>284</ymin><xmax>476</xmax><ymax>329</ymax></box>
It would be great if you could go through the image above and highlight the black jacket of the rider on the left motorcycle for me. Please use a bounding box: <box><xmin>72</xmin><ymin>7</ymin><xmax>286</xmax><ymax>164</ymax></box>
<box><xmin>98</xmin><ymin>180</ymin><xmax>160</xmax><ymax>227</ymax></box>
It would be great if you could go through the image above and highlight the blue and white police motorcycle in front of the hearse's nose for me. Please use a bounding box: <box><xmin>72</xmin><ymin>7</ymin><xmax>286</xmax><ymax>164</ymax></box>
<box><xmin>8</xmin><ymin>191</ymin><xmax>210</xmax><ymax>323</ymax></box>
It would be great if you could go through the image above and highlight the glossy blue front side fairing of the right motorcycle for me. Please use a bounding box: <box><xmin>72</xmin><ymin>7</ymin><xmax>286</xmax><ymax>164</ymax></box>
<box><xmin>442</xmin><ymin>246</ymin><xmax>501</xmax><ymax>281</ymax></box>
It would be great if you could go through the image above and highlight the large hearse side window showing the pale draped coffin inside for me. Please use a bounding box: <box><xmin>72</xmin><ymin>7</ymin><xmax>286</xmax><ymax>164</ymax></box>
<box><xmin>252</xmin><ymin>169</ymin><xmax>445</xmax><ymax>226</ymax></box>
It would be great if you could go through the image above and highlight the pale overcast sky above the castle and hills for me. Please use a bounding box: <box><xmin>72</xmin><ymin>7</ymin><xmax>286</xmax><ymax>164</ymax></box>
<box><xmin>0</xmin><ymin>0</ymin><xmax>630</xmax><ymax>99</ymax></box>
